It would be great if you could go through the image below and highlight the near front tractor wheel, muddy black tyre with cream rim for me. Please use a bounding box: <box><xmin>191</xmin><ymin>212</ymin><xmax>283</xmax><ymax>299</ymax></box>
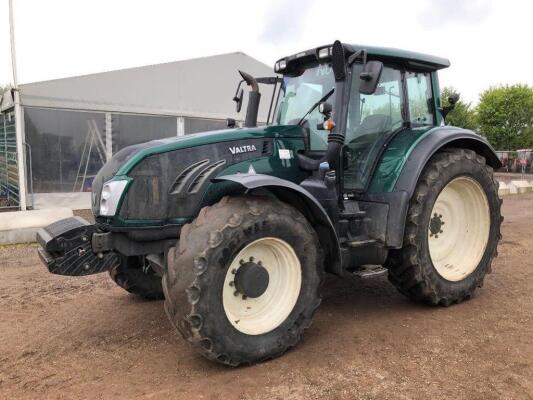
<box><xmin>163</xmin><ymin>197</ymin><xmax>324</xmax><ymax>366</ymax></box>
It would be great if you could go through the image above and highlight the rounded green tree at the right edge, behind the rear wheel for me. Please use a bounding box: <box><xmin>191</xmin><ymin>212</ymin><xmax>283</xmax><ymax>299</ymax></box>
<box><xmin>477</xmin><ymin>84</ymin><xmax>533</xmax><ymax>150</ymax></box>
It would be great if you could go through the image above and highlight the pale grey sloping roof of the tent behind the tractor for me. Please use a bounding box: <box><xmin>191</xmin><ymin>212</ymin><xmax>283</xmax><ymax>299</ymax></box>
<box><xmin>20</xmin><ymin>52</ymin><xmax>274</xmax><ymax>119</ymax></box>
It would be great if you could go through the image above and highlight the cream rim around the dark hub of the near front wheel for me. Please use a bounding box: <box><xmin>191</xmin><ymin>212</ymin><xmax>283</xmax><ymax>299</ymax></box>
<box><xmin>222</xmin><ymin>237</ymin><xmax>302</xmax><ymax>335</ymax></box>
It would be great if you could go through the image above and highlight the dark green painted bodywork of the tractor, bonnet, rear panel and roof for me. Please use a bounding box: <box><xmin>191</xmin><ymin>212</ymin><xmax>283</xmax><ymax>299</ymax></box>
<box><xmin>100</xmin><ymin>45</ymin><xmax>449</xmax><ymax>226</ymax></box>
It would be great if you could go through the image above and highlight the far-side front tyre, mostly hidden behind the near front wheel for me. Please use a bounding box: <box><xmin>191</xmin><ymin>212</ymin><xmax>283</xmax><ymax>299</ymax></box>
<box><xmin>109</xmin><ymin>257</ymin><xmax>164</xmax><ymax>300</ymax></box>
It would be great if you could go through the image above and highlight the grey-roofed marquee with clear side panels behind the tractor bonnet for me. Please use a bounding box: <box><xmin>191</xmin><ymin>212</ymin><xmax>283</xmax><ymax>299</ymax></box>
<box><xmin>0</xmin><ymin>52</ymin><xmax>273</xmax><ymax>210</ymax></box>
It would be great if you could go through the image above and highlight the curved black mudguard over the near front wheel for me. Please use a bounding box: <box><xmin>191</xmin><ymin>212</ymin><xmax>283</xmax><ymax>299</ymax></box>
<box><xmin>212</xmin><ymin>174</ymin><xmax>342</xmax><ymax>275</ymax></box>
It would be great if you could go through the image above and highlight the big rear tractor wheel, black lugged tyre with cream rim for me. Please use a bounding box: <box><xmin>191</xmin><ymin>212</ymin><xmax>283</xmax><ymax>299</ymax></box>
<box><xmin>386</xmin><ymin>149</ymin><xmax>503</xmax><ymax>306</ymax></box>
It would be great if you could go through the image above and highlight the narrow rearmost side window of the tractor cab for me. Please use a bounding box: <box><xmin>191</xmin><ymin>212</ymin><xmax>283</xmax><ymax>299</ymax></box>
<box><xmin>406</xmin><ymin>72</ymin><xmax>434</xmax><ymax>126</ymax></box>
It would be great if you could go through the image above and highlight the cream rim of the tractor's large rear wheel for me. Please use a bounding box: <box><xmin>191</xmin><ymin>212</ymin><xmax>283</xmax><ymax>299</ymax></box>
<box><xmin>428</xmin><ymin>176</ymin><xmax>490</xmax><ymax>282</ymax></box>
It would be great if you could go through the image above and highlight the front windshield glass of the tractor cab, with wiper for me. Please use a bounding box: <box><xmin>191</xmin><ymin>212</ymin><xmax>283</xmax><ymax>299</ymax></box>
<box><xmin>276</xmin><ymin>64</ymin><xmax>335</xmax><ymax>150</ymax></box>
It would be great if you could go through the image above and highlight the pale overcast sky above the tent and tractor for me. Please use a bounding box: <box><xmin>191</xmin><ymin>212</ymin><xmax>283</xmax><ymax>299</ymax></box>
<box><xmin>0</xmin><ymin>0</ymin><xmax>533</xmax><ymax>104</ymax></box>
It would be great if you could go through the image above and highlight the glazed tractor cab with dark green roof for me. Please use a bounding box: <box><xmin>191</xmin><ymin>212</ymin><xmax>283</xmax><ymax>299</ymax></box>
<box><xmin>274</xmin><ymin>42</ymin><xmax>449</xmax><ymax>192</ymax></box>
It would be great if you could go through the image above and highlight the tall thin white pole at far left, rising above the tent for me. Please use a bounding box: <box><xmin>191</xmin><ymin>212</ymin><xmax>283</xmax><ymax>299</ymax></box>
<box><xmin>9</xmin><ymin>0</ymin><xmax>26</xmax><ymax>211</ymax></box>
